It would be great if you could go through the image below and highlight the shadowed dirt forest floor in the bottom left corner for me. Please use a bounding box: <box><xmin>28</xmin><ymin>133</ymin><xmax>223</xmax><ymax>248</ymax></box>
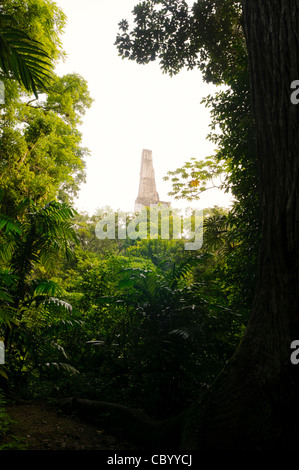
<box><xmin>5</xmin><ymin>401</ymin><xmax>137</xmax><ymax>451</ymax></box>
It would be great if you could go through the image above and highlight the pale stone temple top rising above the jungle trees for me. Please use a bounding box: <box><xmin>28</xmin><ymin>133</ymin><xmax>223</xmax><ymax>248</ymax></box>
<box><xmin>135</xmin><ymin>149</ymin><xmax>170</xmax><ymax>212</ymax></box>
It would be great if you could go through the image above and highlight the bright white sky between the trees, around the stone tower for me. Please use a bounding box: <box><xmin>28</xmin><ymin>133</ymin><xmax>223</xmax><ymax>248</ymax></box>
<box><xmin>56</xmin><ymin>0</ymin><xmax>230</xmax><ymax>215</ymax></box>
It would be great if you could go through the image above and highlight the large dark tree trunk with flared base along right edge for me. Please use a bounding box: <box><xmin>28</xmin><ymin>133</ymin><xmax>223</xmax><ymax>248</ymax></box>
<box><xmin>182</xmin><ymin>0</ymin><xmax>299</xmax><ymax>450</ymax></box>
